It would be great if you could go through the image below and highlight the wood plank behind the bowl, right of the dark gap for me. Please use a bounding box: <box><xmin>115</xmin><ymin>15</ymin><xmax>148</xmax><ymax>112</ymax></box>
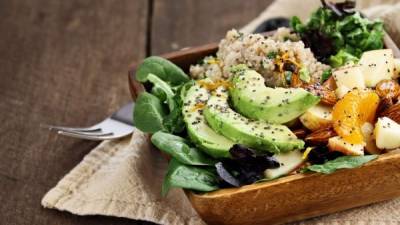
<box><xmin>151</xmin><ymin>0</ymin><xmax>273</xmax><ymax>54</ymax></box>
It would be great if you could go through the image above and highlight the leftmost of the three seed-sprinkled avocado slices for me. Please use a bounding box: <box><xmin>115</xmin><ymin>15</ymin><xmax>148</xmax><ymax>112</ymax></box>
<box><xmin>182</xmin><ymin>84</ymin><xmax>235</xmax><ymax>158</ymax></box>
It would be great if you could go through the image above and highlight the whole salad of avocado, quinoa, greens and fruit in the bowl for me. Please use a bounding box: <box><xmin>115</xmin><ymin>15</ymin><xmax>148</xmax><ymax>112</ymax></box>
<box><xmin>134</xmin><ymin>2</ymin><xmax>400</xmax><ymax>195</ymax></box>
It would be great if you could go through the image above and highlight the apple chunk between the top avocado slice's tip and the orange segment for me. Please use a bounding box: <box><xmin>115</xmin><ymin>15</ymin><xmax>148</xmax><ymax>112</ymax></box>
<box><xmin>300</xmin><ymin>105</ymin><xmax>332</xmax><ymax>131</ymax></box>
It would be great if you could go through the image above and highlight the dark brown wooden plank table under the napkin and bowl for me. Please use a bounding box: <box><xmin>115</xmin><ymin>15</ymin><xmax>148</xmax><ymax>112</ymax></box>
<box><xmin>0</xmin><ymin>0</ymin><xmax>271</xmax><ymax>225</ymax></box>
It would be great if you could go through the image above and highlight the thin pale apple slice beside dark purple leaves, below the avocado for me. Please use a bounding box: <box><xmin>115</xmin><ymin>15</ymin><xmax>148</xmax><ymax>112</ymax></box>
<box><xmin>264</xmin><ymin>150</ymin><xmax>305</xmax><ymax>179</ymax></box>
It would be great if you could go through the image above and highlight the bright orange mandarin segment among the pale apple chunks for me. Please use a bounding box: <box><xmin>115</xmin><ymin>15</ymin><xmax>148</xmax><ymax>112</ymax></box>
<box><xmin>332</xmin><ymin>90</ymin><xmax>379</xmax><ymax>144</ymax></box>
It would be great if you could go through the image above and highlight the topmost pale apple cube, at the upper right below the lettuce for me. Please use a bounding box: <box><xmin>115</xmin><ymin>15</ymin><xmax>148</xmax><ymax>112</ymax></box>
<box><xmin>358</xmin><ymin>49</ymin><xmax>394</xmax><ymax>87</ymax></box>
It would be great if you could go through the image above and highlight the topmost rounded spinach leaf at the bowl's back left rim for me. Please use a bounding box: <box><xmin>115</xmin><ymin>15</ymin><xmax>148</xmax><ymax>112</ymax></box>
<box><xmin>136</xmin><ymin>56</ymin><xmax>190</xmax><ymax>85</ymax></box>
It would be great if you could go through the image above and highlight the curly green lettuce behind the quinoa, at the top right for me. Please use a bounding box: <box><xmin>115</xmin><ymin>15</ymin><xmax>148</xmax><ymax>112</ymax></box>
<box><xmin>290</xmin><ymin>7</ymin><xmax>384</xmax><ymax>67</ymax></box>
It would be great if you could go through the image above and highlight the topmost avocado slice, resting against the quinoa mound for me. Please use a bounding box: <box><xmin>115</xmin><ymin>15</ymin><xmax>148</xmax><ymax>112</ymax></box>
<box><xmin>230</xmin><ymin>69</ymin><xmax>319</xmax><ymax>124</ymax></box>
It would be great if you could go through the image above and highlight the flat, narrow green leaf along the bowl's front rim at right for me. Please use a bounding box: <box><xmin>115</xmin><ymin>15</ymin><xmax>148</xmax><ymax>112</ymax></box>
<box><xmin>301</xmin><ymin>155</ymin><xmax>378</xmax><ymax>174</ymax></box>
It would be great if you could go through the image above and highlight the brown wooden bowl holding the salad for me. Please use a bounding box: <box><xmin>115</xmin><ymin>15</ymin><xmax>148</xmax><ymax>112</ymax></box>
<box><xmin>129</xmin><ymin>32</ymin><xmax>400</xmax><ymax>225</ymax></box>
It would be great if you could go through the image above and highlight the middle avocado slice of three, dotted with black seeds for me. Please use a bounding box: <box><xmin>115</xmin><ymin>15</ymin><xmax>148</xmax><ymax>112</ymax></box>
<box><xmin>204</xmin><ymin>87</ymin><xmax>304</xmax><ymax>153</ymax></box>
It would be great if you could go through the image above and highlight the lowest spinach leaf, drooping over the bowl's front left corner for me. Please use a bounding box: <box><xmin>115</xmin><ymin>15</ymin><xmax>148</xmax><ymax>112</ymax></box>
<box><xmin>161</xmin><ymin>159</ymin><xmax>219</xmax><ymax>196</ymax></box>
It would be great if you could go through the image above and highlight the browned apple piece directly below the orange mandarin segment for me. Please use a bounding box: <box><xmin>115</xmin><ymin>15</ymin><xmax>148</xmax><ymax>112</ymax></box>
<box><xmin>328</xmin><ymin>136</ymin><xmax>366</xmax><ymax>155</ymax></box>
